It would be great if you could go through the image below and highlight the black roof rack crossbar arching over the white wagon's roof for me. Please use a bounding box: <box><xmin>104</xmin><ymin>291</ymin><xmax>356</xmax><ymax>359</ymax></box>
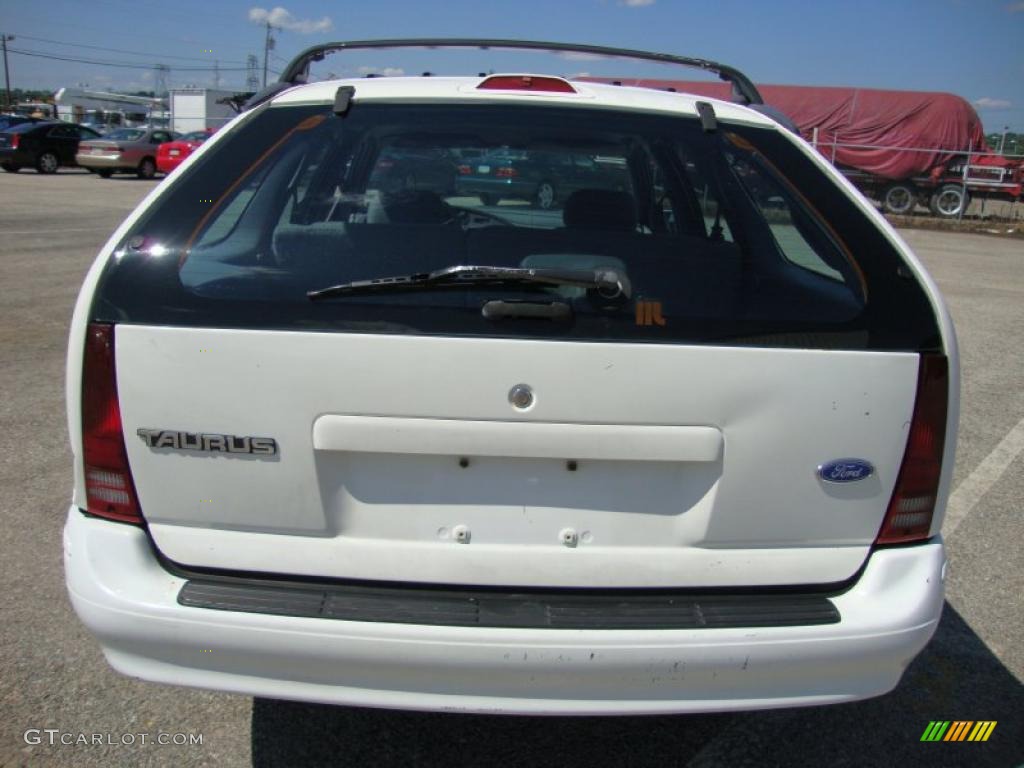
<box><xmin>274</xmin><ymin>38</ymin><xmax>764</xmax><ymax>104</ymax></box>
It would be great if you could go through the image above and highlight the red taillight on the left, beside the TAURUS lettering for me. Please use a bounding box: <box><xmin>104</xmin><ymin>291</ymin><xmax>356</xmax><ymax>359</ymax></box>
<box><xmin>82</xmin><ymin>323</ymin><xmax>142</xmax><ymax>522</ymax></box>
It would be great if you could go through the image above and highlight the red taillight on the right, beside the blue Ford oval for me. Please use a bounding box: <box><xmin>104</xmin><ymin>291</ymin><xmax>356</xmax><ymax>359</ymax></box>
<box><xmin>874</xmin><ymin>355</ymin><xmax>949</xmax><ymax>544</ymax></box>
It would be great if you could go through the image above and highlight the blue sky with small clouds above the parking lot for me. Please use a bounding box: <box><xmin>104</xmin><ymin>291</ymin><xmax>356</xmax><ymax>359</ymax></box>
<box><xmin>0</xmin><ymin>0</ymin><xmax>1024</xmax><ymax>133</ymax></box>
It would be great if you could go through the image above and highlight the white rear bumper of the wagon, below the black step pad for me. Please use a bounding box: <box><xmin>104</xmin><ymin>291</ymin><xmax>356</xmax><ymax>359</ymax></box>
<box><xmin>65</xmin><ymin>508</ymin><xmax>945</xmax><ymax>715</ymax></box>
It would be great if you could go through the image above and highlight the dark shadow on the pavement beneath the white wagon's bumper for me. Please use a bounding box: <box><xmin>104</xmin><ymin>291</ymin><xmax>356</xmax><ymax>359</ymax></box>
<box><xmin>252</xmin><ymin>603</ymin><xmax>1024</xmax><ymax>768</ymax></box>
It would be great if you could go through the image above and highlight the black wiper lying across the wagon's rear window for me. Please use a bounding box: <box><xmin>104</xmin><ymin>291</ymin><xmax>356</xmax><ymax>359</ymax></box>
<box><xmin>306</xmin><ymin>264</ymin><xmax>631</xmax><ymax>301</ymax></box>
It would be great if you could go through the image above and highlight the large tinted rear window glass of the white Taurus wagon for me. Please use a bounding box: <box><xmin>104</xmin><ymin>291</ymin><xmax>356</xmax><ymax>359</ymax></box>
<box><xmin>96</xmin><ymin>101</ymin><xmax>937</xmax><ymax>348</ymax></box>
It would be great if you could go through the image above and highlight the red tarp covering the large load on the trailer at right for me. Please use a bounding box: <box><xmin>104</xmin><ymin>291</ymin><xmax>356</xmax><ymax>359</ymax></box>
<box><xmin>580</xmin><ymin>77</ymin><xmax>988</xmax><ymax>179</ymax></box>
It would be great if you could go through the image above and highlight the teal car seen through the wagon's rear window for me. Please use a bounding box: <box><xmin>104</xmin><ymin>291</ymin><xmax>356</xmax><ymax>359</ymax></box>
<box><xmin>456</xmin><ymin>148</ymin><xmax>630</xmax><ymax>209</ymax></box>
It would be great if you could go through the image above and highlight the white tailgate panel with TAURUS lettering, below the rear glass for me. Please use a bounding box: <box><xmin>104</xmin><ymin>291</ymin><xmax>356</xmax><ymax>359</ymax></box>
<box><xmin>117</xmin><ymin>326</ymin><xmax>919</xmax><ymax>587</ymax></box>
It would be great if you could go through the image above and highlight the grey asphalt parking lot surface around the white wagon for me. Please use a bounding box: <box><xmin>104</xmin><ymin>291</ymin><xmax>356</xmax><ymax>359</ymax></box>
<box><xmin>0</xmin><ymin>171</ymin><xmax>1024</xmax><ymax>768</ymax></box>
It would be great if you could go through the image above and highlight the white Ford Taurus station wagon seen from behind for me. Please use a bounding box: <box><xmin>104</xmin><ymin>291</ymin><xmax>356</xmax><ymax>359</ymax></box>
<box><xmin>65</xmin><ymin>40</ymin><xmax>958</xmax><ymax>715</ymax></box>
